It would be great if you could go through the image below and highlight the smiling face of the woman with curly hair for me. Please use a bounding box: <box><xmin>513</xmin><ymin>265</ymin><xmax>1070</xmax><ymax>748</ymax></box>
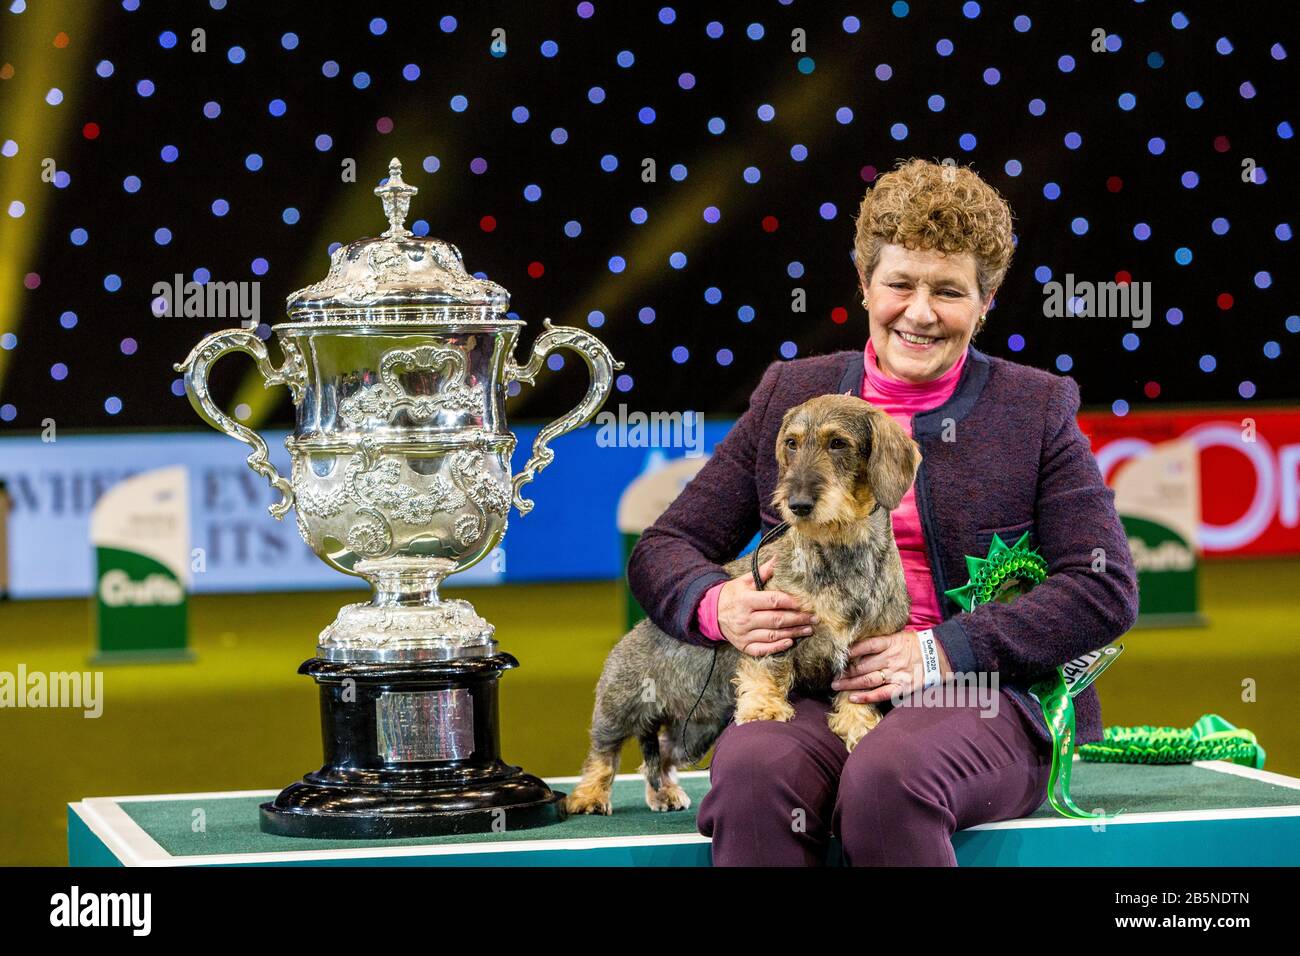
<box><xmin>862</xmin><ymin>245</ymin><xmax>996</xmax><ymax>382</ymax></box>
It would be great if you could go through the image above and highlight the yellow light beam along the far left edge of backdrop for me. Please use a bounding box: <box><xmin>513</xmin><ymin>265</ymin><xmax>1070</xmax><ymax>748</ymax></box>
<box><xmin>0</xmin><ymin>0</ymin><xmax>100</xmax><ymax>386</ymax></box>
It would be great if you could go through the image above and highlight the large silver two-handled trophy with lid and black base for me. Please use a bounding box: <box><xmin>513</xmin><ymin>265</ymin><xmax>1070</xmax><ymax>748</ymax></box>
<box><xmin>176</xmin><ymin>159</ymin><xmax>623</xmax><ymax>838</ymax></box>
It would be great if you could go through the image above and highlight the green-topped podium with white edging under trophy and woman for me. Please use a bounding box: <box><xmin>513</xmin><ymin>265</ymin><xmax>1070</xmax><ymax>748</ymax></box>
<box><xmin>68</xmin><ymin>760</ymin><xmax>1300</xmax><ymax>866</ymax></box>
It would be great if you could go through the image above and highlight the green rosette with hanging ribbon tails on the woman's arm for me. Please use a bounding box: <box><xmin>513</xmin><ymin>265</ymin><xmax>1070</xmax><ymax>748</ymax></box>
<box><xmin>944</xmin><ymin>532</ymin><xmax>1125</xmax><ymax>819</ymax></box>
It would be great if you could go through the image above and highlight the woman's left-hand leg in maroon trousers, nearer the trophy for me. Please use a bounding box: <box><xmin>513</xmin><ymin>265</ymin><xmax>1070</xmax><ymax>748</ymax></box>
<box><xmin>697</xmin><ymin>695</ymin><xmax>849</xmax><ymax>866</ymax></box>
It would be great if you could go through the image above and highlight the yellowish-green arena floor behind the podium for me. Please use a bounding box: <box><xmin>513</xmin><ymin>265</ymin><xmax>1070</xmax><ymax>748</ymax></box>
<box><xmin>0</xmin><ymin>559</ymin><xmax>1300</xmax><ymax>865</ymax></box>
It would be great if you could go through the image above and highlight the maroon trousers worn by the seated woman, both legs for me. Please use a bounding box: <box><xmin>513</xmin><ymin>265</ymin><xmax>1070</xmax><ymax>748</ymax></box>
<box><xmin>697</xmin><ymin>692</ymin><xmax>1052</xmax><ymax>866</ymax></box>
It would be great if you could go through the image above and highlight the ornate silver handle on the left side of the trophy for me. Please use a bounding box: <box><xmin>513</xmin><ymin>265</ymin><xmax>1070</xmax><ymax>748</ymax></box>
<box><xmin>174</xmin><ymin>329</ymin><xmax>307</xmax><ymax>519</ymax></box>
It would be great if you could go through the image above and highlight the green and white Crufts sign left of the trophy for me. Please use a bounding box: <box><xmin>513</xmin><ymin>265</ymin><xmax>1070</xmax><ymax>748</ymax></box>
<box><xmin>90</xmin><ymin>467</ymin><xmax>192</xmax><ymax>663</ymax></box>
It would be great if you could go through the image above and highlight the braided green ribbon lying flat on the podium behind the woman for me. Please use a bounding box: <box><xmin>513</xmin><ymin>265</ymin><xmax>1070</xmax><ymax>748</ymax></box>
<box><xmin>1079</xmin><ymin>714</ymin><xmax>1266</xmax><ymax>770</ymax></box>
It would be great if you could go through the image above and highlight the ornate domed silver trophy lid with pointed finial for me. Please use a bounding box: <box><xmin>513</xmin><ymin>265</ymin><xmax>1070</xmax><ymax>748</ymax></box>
<box><xmin>287</xmin><ymin>157</ymin><xmax>510</xmax><ymax>321</ymax></box>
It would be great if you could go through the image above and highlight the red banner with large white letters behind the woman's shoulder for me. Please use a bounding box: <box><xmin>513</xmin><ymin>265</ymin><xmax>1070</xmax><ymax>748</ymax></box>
<box><xmin>1079</xmin><ymin>407</ymin><xmax>1300</xmax><ymax>555</ymax></box>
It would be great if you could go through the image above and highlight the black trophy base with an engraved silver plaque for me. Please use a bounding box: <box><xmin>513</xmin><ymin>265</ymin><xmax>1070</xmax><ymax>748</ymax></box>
<box><xmin>260</xmin><ymin>653</ymin><xmax>566</xmax><ymax>840</ymax></box>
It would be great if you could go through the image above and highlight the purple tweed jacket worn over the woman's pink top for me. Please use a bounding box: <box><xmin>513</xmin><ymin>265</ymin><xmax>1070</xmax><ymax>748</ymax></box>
<box><xmin>627</xmin><ymin>347</ymin><xmax>1138</xmax><ymax>745</ymax></box>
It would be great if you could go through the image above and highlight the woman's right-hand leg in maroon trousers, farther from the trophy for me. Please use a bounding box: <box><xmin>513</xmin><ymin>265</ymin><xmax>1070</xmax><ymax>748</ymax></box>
<box><xmin>832</xmin><ymin>692</ymin><xmax>1052</xmax><ymax>866</ymax></box>
